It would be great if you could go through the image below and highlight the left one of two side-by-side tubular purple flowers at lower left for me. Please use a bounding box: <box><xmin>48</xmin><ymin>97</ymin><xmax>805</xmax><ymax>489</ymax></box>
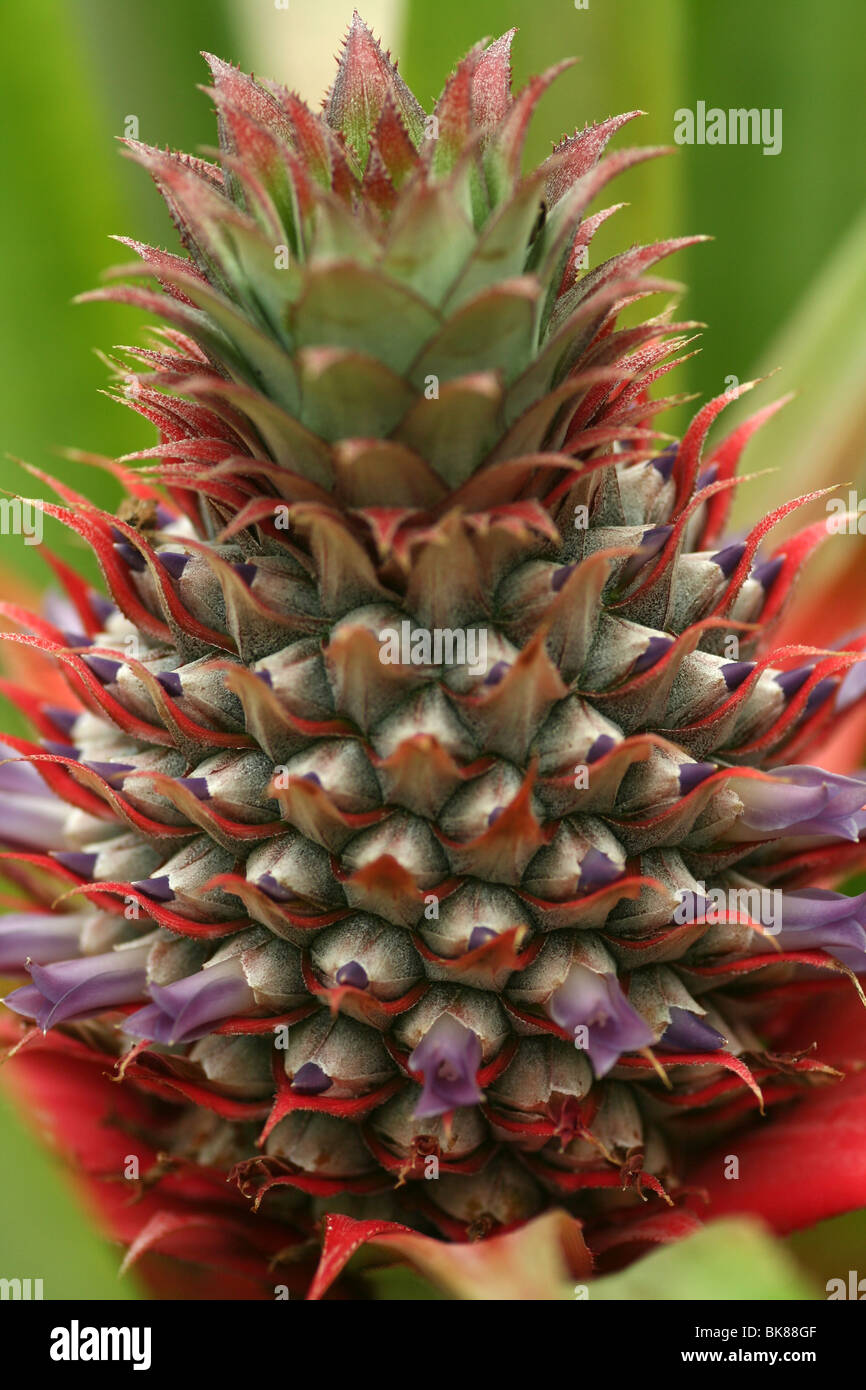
<box><xmin>4</xmin><ymin>944</ymin><xmax>150</xmax><ymax>1033</ymax></box>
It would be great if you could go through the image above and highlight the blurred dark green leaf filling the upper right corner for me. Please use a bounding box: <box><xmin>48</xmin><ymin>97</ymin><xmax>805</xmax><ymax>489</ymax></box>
<box><xmin>681</xmin><ymin>0</ymin><xmax>863</xmax><ymax>419</ymax></box>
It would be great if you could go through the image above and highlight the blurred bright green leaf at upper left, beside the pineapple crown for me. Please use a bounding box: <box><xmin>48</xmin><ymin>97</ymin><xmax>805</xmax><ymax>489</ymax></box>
<box><xmin>0</xmin><ymin>0</ymin><xmax>232</xmax><ymax>582</ymax></box>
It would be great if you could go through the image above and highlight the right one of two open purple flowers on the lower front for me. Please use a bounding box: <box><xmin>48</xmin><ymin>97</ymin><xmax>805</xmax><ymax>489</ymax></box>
<box><xmin>548</xmin><ymin>965</ymin><xmax>653</xmax><ymax>1076</ymax></box>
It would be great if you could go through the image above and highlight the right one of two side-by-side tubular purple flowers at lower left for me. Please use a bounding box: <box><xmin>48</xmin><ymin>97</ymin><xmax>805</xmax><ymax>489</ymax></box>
<box><xmin>124</xmin><ymin>956</ymin><xmax>256</xmax><ymax>1045</ymax></box>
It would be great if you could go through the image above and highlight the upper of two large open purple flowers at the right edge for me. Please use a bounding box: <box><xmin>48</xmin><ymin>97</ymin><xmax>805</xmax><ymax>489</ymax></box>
<box><xmin>737</xmin><ymin>766</ymin><xmax>866</xmax><ymax>840</ymax></box>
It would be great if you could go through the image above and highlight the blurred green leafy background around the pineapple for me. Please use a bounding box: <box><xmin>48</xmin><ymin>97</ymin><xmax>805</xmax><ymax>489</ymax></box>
<box><xmin>0</xmin><ymin>0</ymin><xmax>866</xmax><ymax>1298</ymax></box>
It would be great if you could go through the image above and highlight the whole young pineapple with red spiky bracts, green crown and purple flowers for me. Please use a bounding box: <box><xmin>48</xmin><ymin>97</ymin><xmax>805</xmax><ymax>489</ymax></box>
<box><xmin>0</xmin><ymin>18</ymin><xmax>866</xmax><ymax>1267</ymax></box>
